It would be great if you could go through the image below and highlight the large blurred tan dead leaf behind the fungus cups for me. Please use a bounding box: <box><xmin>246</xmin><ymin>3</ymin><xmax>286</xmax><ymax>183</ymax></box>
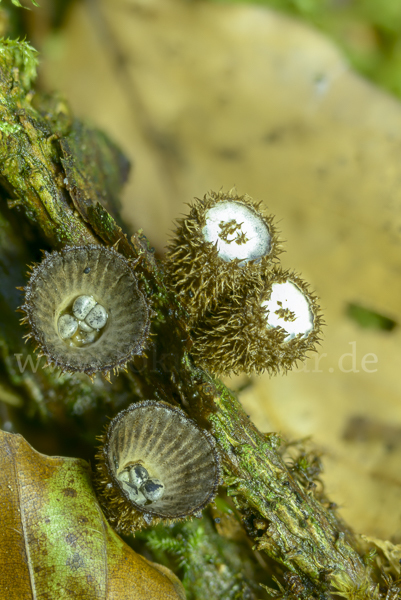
<box><xmin>30</xmin><ymin>0</ymin><xmax>401</xmax><ymax>542</ymax></box>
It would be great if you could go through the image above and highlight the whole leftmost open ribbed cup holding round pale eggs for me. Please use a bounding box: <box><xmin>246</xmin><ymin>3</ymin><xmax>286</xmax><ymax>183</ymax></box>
<box><xmin>21</xmin><ymin>244</ymin><xmax>149</xmax><ymax>377</ymax></box>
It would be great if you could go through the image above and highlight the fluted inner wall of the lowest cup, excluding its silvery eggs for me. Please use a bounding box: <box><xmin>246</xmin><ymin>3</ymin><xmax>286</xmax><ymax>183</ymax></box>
<box><xmin>107</xmin><ymin>401</ymin><xmax>219</xmax><ymax>518</ymax></box>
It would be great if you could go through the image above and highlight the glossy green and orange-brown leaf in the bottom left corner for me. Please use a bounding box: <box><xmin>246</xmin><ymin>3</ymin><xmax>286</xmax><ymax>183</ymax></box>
<box><xmin>0</xmin><ymin>432</ymin><xmax>185</xmax><ymax>600</ymax></box>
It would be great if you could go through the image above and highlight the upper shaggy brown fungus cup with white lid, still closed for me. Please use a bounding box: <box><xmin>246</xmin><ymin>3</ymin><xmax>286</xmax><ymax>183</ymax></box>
<box><xmin>166</xmin><ymin>190</ymin><xmax>280</xmax><ymax>321</ymax></box>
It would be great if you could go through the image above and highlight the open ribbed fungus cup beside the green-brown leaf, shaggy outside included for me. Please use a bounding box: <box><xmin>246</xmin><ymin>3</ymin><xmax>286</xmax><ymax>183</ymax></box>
<box><xmin>96</xmin><ymin>400</ymin><xmax>220</xmax><ymax>533</ymax></box>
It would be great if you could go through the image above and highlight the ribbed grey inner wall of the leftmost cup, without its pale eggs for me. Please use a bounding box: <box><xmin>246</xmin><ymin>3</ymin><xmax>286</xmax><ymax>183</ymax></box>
<box><xmin>26</xmin><ymin>245</ymin><xmax>149</xmax><ymax>372</ymax></box>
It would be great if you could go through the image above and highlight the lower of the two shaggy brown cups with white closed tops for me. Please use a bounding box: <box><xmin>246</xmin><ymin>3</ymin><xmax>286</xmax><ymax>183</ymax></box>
<box><xmin>191</xmin><ymin>267</ymin><xmax>323</xmax><ymax>375</ymax></box>
